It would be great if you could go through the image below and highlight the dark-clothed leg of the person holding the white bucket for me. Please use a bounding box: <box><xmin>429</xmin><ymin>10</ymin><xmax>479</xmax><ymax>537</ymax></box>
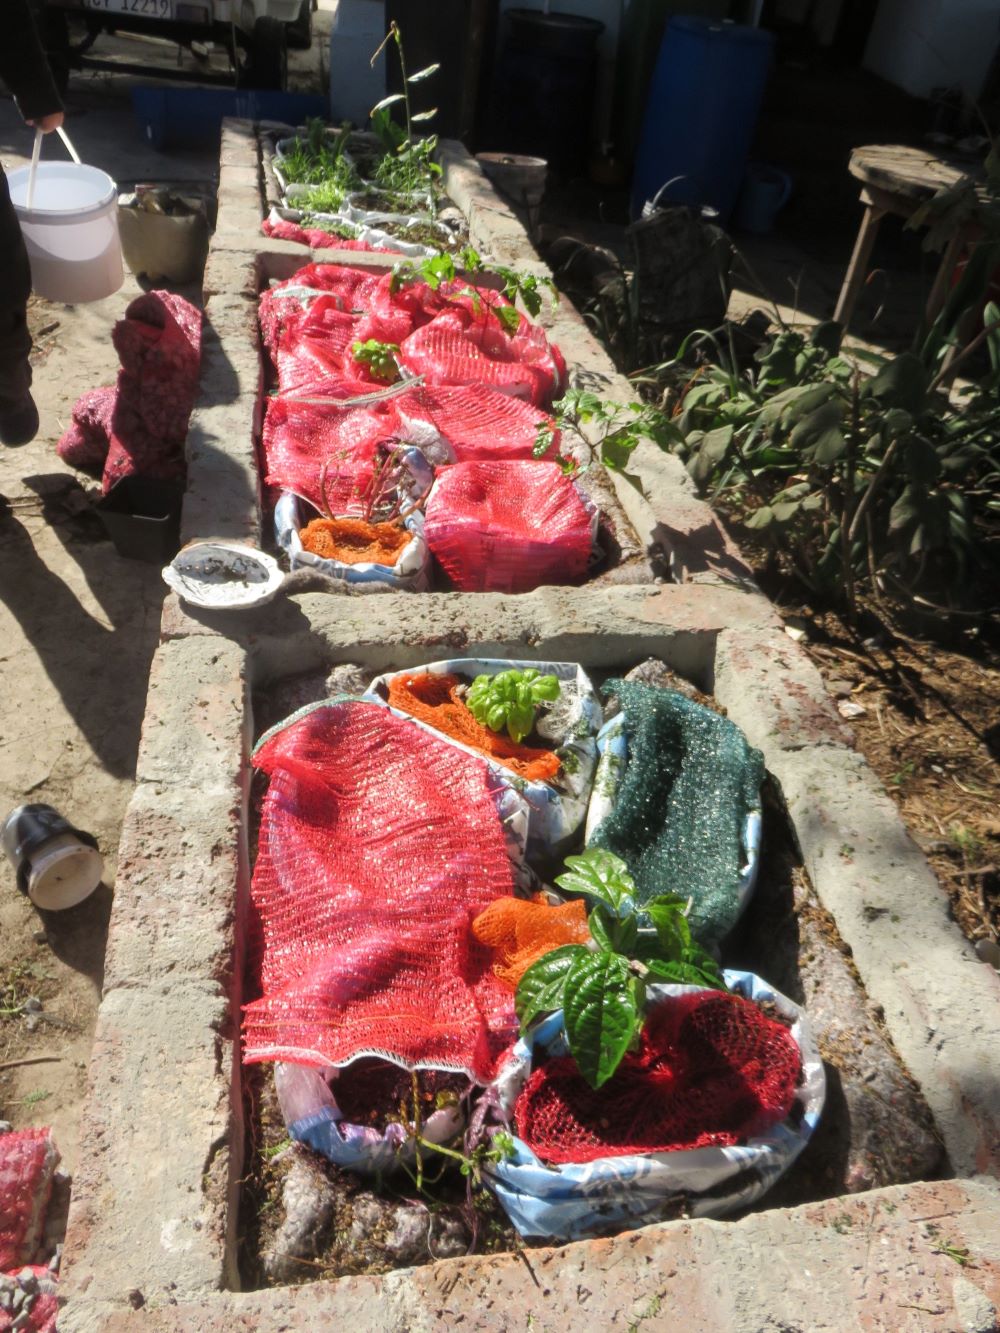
<box><xmin>0</xmin><ymin>171</ymin><xmax>39</xmax><ymax>444</ymax></box>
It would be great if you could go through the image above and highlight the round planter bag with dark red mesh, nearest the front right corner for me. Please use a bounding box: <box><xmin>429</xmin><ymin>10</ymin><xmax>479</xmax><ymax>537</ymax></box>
<box><xmin>484</xmin><ymin>972</ymin><xmax>825</xmax><ymax>1241</ymax></box>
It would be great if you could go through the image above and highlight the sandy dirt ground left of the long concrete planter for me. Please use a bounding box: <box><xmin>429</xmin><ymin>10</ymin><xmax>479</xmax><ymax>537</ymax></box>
<box><xmin>0</xmin><ymin>18</ymin><xmax>329</xmax><ymax>1170</ymax></box>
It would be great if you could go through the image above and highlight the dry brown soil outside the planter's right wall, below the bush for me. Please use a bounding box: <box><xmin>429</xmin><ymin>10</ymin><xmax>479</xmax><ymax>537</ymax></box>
<box><xmin>744</xmin><ymin>557</ymin><xmax>1000</xmax><ymax>941</ymax></box>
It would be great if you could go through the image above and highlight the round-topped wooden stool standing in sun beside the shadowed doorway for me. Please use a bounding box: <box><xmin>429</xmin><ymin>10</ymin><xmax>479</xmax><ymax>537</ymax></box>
<box><xmin>833</xmin><ymin>144</ymin><xmax>979</xmax><ymax>329</ymax></box>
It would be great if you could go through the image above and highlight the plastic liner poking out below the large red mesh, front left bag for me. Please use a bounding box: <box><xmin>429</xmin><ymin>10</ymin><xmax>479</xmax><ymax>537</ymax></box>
<box><xmin>275</xmin><ymin>1062</ymin><xmax>465</xmax><ymax>1174</ymax></box>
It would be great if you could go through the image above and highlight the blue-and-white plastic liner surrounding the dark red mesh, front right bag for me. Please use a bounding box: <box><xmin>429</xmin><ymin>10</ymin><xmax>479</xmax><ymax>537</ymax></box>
<box><xmin>483</xmin><ymin>972</ymin><xmax>827</xmax><ymax>1241</ymax></box>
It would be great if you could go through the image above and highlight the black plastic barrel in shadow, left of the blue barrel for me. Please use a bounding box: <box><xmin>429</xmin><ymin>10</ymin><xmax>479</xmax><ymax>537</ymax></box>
<box><xmin>492</xmin><ymin>9</ymin><xmax>604</xmax><ymax>176</ymax></box>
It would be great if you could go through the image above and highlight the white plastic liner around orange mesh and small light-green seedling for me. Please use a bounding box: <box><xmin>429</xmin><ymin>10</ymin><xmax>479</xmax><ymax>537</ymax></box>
<box><xmin>364</xmin><ymin>657</ymin><xmax>603</xmax><ymax>860</ymax></box>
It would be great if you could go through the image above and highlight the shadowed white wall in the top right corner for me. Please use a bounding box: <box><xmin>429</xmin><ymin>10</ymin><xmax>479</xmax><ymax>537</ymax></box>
<box><xmin>864</xmin><ymin>0</ymin><xmax>1000</xmax><ymax>97</ymax></box>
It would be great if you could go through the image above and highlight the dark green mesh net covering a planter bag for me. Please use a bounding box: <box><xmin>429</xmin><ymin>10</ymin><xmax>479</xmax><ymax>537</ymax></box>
<box><xmin>591</xmin><ymin>680</ymin><xmax>764</xmax><ymax>944</ymax></box>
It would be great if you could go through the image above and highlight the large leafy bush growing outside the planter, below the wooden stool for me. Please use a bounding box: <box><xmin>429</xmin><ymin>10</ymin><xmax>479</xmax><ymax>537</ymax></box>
<box><xmin>659</xmin><ymin>324</ymin><xmax>1000</xmax><ymax>615</ymax></box>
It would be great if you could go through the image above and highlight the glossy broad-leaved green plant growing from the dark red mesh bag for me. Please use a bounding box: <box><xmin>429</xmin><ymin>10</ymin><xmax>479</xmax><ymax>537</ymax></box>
<box><xmin>515</xmin><ymin>848</ymin><xmax>725</xmax><ymax>1088</ymax></box>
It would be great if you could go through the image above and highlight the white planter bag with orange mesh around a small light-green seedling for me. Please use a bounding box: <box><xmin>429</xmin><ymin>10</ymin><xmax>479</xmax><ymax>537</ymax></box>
<box><xmin>365</xmin><ymin>657</ymin><xmax>601</xmax><ymax>860</ymax></box>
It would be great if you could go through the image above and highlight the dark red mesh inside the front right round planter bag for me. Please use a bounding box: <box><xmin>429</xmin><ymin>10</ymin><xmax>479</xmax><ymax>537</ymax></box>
<box><xmin>515</xmin><ymin>992</ymin><xmax>801</xmax><ymax>1164</ymax></box>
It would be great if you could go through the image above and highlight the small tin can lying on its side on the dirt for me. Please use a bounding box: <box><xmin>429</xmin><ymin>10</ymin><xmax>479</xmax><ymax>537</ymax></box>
<box><xmin>0</xmin><ymin>805</ymin><xmax>104</xmax><ymax>912</ymax></box>
